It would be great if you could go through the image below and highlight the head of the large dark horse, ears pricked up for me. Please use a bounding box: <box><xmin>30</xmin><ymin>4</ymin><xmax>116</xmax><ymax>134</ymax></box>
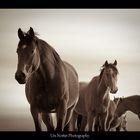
<box><xmin>15</xmin><ymin>27</ymin><xmax>40</xmax><ymax>84</ymax></box>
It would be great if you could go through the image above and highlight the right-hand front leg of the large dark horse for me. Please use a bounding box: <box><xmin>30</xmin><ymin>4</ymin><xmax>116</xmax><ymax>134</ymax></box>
<box><xmin>56</xmin><ymin>100</ymin><xmax>67</xmax><ymax>131</ymax></box>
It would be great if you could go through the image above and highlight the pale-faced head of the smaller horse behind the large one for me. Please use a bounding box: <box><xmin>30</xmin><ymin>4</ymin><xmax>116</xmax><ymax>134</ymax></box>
<box><xmin>103</xmin><ymin>60</ymin><xmax>118</xmax><ymax>93</ymax></box>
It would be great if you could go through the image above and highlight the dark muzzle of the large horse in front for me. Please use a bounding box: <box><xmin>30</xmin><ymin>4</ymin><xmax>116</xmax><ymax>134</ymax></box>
<box><xmin>15</xmin><ymin>72</ymin><xmax>26</xmax><ymax>84</ymax></box>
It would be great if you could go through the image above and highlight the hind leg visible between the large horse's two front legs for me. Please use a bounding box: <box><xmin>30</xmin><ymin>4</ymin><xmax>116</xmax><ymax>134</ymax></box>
<box><xmin>42</xmin><ymin>112</ymin><xmax>54</xmax><ymax>131</ymax></box>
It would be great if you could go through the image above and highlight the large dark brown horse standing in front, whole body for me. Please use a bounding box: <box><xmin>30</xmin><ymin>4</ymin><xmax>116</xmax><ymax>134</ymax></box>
<box><xmin>15</xmin><ymin>27</ymin><xmax>79</xmax><ymax>131</ymax></box>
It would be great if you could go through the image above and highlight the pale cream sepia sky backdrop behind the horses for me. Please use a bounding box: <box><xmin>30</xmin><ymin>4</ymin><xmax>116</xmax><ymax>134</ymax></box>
<box><xmin>0</xmin><ymin>9</ymin><xmax>140</xmax><ymax>131</ymax></box>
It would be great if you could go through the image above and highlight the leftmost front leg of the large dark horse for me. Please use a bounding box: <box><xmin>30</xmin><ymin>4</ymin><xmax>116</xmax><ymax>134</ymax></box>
<box><xmin>30</xmin><ymin>106</ymin><xmax>42</xmax><ymax>131</ymax></box>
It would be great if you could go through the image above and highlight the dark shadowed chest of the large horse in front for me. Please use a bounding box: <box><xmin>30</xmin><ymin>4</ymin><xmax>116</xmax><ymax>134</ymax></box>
<box><xmin>27</xmin><ymin>77</ymin><xmax>61</xmax><ymax>112</ymax></box>
